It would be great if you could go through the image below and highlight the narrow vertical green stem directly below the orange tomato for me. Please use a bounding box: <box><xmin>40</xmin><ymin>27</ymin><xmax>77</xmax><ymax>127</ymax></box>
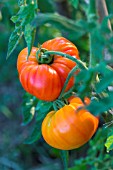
<box><xmin>60</xmin><ymin>150</ymin><xmax>69</xmax><ymax>170</ymax></box>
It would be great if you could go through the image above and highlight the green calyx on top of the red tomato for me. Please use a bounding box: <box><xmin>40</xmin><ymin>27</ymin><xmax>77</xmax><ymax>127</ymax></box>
<box><xmin>36</xmin><ymin>48</ymin><xmax>54</xmax><ymax>64</ymax></box>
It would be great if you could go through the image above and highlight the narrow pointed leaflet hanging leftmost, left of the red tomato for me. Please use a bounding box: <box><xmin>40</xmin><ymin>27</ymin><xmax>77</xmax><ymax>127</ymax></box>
<box><xmin>7</xmin><ymin>27</ymin><xmax>23</xmax><ymax>58</ymax></box>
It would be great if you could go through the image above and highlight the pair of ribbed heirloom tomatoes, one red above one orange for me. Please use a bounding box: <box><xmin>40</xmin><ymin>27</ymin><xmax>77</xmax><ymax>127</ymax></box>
<box><xmin>17</xmin><ymin>37</ymin><xmax>99</xmax><ymax>150</ymax></box>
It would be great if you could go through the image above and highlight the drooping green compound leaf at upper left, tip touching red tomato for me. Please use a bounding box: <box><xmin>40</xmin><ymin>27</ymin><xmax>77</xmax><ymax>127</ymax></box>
<box><xmin>7</xmin><ymin>0</ymin><xmax>37</xmax><ymax>58</ymax></box>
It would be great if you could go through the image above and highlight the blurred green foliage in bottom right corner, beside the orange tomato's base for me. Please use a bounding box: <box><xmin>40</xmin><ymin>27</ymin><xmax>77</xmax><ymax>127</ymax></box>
<box><xmin>69</xmin><ymin>128</ymin><xmax>113</xmax><ymax>170</ymax></box>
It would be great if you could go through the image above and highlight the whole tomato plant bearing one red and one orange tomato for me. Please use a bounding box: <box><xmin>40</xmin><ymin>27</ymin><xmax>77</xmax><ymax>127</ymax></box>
<box><xmin>8</xmin><ymin>0</ymin><xmax>113</xmax><ymax>170</ymax></box>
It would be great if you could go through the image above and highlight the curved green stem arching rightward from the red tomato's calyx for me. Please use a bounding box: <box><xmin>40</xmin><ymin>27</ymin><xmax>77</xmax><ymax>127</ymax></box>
<box><xmin>44</xmin><ymin>51</ymin><xmax>88</xmax><ymax>69</ymax></box>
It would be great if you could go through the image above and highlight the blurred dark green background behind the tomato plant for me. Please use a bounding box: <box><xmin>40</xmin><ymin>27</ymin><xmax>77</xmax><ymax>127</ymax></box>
<box><xmin>0</xmin><ymin>0</ymin><xmax>113</xmax><ymax>170</ymax></box>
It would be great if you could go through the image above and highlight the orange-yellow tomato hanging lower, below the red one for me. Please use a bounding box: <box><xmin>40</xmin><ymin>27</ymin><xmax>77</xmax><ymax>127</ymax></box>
<box><xmin>42</xmin><ymin>97</ymin><xmax>99</xmax><ymax>150</ymax></box>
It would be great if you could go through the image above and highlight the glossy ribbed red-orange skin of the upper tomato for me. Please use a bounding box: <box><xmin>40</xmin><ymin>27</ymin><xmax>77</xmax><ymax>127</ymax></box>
<box><xmin>17</xmin><ymin>37</ymin><xmax>79</xmax><ymax>101</ymax></box>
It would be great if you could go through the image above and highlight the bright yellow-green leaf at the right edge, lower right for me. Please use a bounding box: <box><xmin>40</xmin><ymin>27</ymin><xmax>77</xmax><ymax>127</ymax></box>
<box><xmin>105</xmin><ymin>129</ymin><xmax>113</xmax><ymax>152</ymax></box>
